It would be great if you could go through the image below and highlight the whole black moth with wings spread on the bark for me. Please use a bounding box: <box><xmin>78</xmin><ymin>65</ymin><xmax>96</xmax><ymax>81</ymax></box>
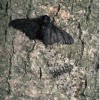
<box><xmin>9</xmin><ymin>15</ymin><xmax>74</xmax><ymax>45</ymax></box>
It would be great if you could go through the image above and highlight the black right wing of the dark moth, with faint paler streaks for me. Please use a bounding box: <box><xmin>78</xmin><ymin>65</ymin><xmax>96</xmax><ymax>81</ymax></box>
<box><xmin>43</xmin><ymin>23</ymin><xmax>74</xmax><ymax>45</ymax></box>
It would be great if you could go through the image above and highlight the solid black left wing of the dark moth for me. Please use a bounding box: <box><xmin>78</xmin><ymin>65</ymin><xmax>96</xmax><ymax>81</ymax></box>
<box><xmin>9</xmin><ymin>18</ymin><xmax>42</xmax><ymax>40</ymax></box>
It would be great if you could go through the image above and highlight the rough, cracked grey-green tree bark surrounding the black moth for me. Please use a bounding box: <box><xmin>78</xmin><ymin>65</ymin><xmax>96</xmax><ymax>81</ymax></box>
<box><xmin>0</xmin><ymin>0</ymin><xmax>99</xmax><ymax>100</ymax></box>
